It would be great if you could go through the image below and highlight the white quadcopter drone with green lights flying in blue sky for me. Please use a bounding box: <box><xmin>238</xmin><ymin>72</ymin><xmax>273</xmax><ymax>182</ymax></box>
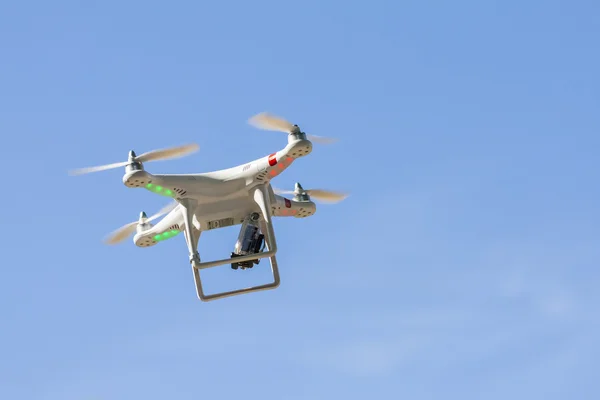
<box><xmin>70</xmin><ymin>112</ymin><xmax>348</xmax><ymax>302</ymax></box>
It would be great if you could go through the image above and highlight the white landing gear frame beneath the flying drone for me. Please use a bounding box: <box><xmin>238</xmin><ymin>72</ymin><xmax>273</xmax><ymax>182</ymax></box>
<box><xmin>184</xmin><ymin>186</ymin><xmax>280</xmax><ymax>301</ymax></box>
